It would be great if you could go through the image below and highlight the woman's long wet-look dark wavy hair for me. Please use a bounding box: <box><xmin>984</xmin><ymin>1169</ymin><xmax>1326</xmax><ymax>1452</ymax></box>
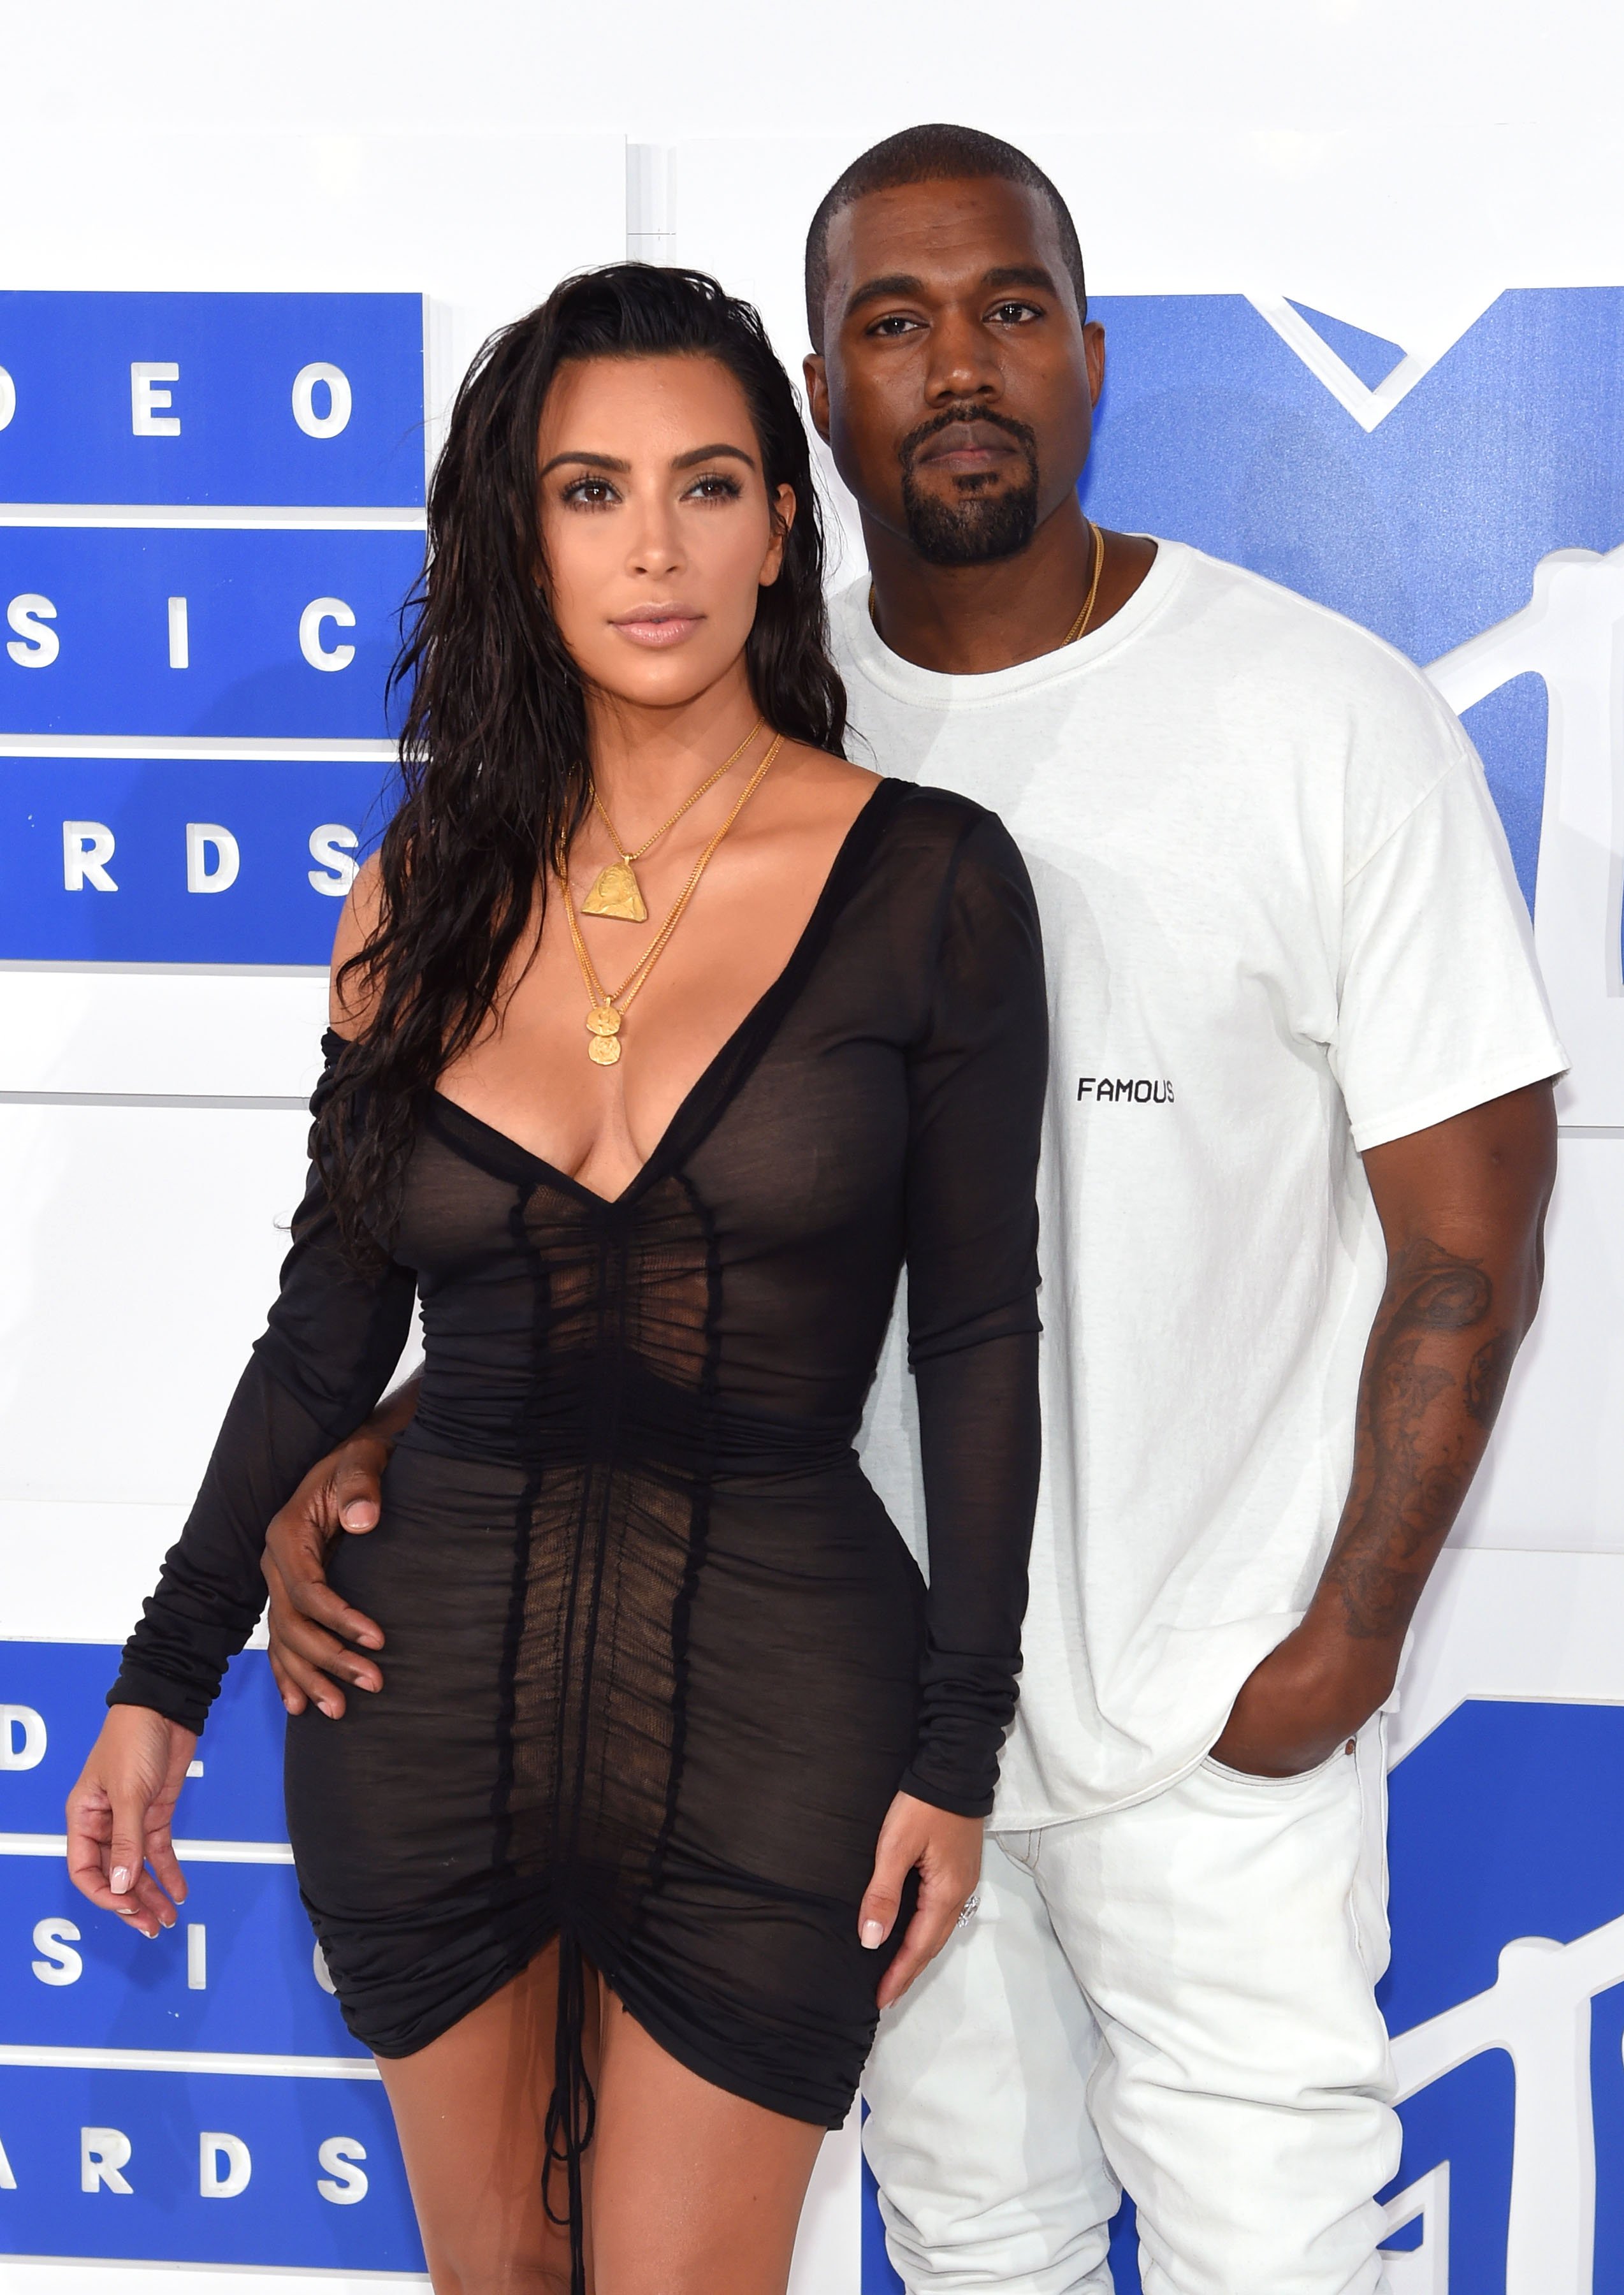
<box><xmin>312</xmin><ymin>264</ymin><xmax>846</xmax><ymax>1265</ymax></box>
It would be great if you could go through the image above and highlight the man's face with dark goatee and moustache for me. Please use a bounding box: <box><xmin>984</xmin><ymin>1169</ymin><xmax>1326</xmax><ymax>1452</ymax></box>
<box><xmin>805</xmin><ymin>177</ymin><xmax>1106</xmax><ymax>565</ymax></box>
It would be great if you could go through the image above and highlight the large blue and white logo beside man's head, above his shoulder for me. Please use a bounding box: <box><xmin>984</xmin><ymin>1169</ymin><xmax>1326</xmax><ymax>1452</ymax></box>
<box><xmin>1083</xmin><ymin>287</ymin><xmax>1624</xmax><ymax>1125</ymax></box>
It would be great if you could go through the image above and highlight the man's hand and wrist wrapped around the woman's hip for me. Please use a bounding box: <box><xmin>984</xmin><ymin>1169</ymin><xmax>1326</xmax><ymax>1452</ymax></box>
<box><xmin>261</xmin><ymin>1370</ymin><xmax>422</xmax><ymax>1721</ymax></box>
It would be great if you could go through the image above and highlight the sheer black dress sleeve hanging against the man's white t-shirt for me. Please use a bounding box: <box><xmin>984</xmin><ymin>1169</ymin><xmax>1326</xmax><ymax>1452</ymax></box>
<box><xmin>901</xmin><ymin>815</ymin><xmax>1048</xmax><ymax>1818</ymax></box>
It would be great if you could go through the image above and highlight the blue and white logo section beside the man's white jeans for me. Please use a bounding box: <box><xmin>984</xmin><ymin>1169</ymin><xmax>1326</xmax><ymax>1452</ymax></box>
<box><xmin>1379</xmin><ymin>1701</ymin><xmax>1624</xmax><ymax>2295</ymax></box>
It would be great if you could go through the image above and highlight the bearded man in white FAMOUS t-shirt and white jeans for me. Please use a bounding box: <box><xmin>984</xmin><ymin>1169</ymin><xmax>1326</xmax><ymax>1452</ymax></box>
<box><xmin>268</xmin><ymin>126</ymin><xmax>1562</xmax><ymax>2295</ymax></box>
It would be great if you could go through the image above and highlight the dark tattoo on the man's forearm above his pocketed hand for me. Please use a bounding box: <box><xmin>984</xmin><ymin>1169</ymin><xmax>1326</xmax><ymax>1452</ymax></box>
<box><xmin>1324</xmin><ymin>1237</ymin><xmax>1521</xmax><ymax>1641</ymax></box>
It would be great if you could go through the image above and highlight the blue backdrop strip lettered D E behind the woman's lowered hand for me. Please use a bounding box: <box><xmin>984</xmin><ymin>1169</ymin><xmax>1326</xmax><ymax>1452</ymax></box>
<box><xmin>0</xmin><ymin>1652</ymin><xmax>287</xmax><ymax>1845</ymax></box>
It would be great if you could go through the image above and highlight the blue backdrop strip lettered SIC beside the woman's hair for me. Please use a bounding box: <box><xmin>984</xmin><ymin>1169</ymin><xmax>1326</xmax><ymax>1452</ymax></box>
<box><xmin>0</xmin><ymin>525</ymin><xmax>422</xmax><ymax>741</ymax></box>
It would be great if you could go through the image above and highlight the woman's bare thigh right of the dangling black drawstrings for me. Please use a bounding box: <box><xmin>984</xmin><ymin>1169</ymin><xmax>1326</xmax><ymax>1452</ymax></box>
<box><xmin>590</xmin><ymin>1992</ymin><xmax>823</xmax><ymax>2295</ymax></box>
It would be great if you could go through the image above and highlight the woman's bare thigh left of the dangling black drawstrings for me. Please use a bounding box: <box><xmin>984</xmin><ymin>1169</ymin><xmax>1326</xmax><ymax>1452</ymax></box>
<box><xmin>379</xmin><ymin>1944</ymin><xmax>597</xmax><ymax>2295</ymax></box>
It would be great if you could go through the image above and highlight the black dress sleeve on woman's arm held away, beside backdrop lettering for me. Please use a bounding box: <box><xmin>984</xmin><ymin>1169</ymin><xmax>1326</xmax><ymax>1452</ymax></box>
<box><xmin>108</xmin><ymin>1035</ymin><xmax>415</xmax><ymax>1730</ymax></box>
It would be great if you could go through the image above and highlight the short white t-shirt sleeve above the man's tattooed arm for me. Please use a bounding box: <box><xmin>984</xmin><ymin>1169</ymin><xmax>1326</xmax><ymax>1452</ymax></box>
<box><xmin>1330</xmin><ymin>743</ymin><xmax>1567</xmax><ymax>1150</ymax></box>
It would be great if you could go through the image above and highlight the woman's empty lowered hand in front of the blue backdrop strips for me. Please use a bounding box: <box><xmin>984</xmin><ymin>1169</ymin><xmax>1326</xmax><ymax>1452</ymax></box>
<box><xmin>66</xmin><ymin>1705</ymin><xmax>198</xmax><ymax>1937</ymax></box>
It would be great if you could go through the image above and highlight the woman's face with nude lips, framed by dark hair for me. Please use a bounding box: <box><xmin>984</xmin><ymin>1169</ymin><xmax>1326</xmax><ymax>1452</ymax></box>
<box><xmin>537</xmin><ymin>356</ymin><xmax>794</xmax><ymax>707</ymax></box>
